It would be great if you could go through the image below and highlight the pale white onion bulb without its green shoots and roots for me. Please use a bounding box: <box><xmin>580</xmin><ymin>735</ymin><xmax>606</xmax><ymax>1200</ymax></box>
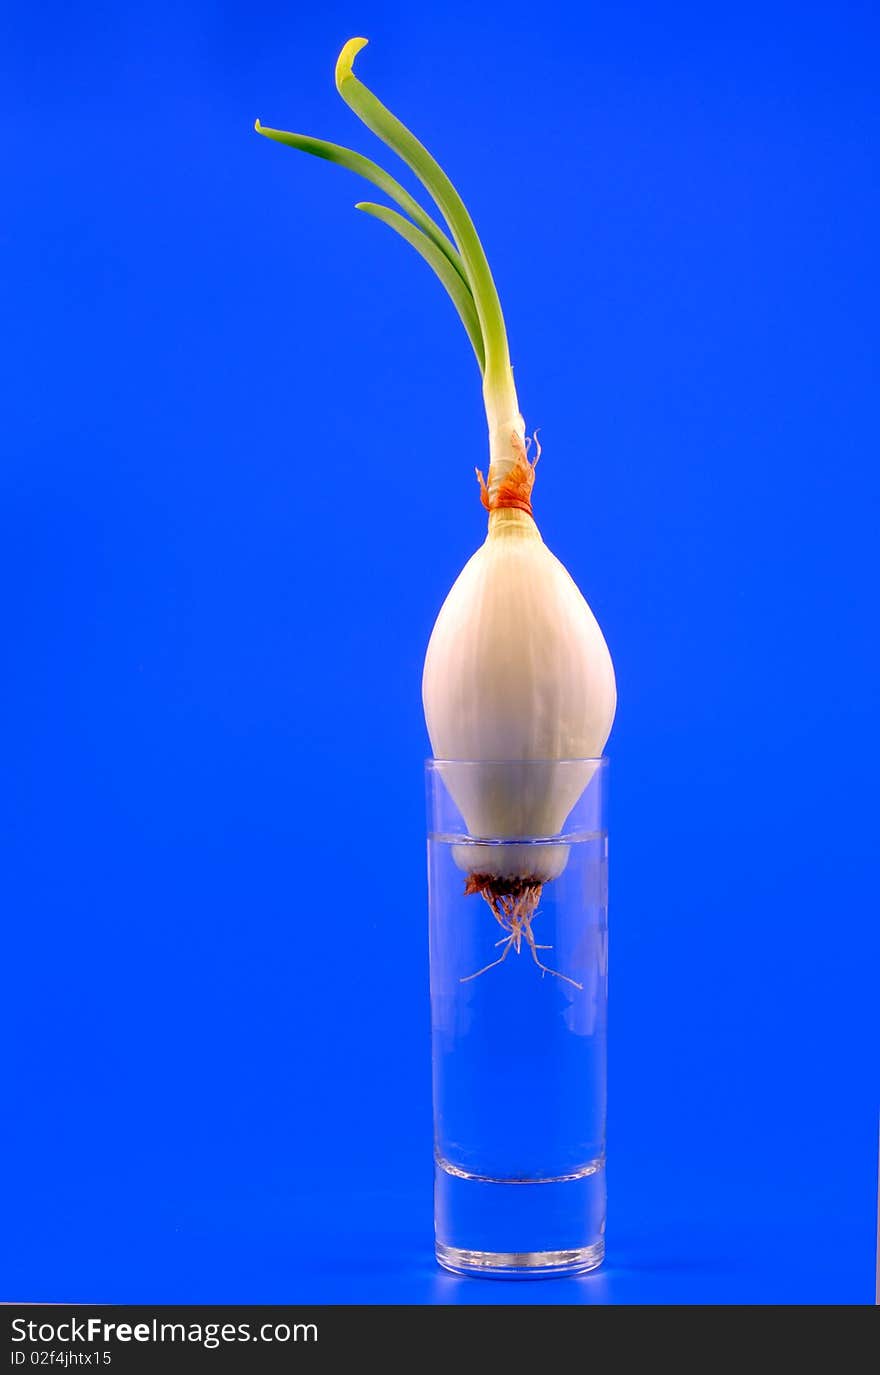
<box><xmin>422</xmin><ymin>509</ymin><xmax>617</xmax><ymax>881</ymax></box>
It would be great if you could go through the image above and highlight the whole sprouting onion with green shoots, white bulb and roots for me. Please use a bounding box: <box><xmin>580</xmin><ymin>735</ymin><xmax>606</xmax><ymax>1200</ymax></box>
<box><xmin>256</xmin><ymin>39</ymin><xmax>617</xmax><ymax>983</ymax></box>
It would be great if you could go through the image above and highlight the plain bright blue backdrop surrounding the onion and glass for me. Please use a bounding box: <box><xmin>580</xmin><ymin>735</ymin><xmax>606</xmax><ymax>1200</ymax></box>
<box><xmin>0</xmin><ymin>0</ymin><xmax>880</xmax><ymax>1304</ymax></box>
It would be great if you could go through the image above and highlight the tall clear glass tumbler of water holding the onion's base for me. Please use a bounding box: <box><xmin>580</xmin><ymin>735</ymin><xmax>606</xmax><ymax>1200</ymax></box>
<box><xmin>426</xmin><ymin>759</ymin><xmax>608</xmax><ymax>1277</ymax></box>
